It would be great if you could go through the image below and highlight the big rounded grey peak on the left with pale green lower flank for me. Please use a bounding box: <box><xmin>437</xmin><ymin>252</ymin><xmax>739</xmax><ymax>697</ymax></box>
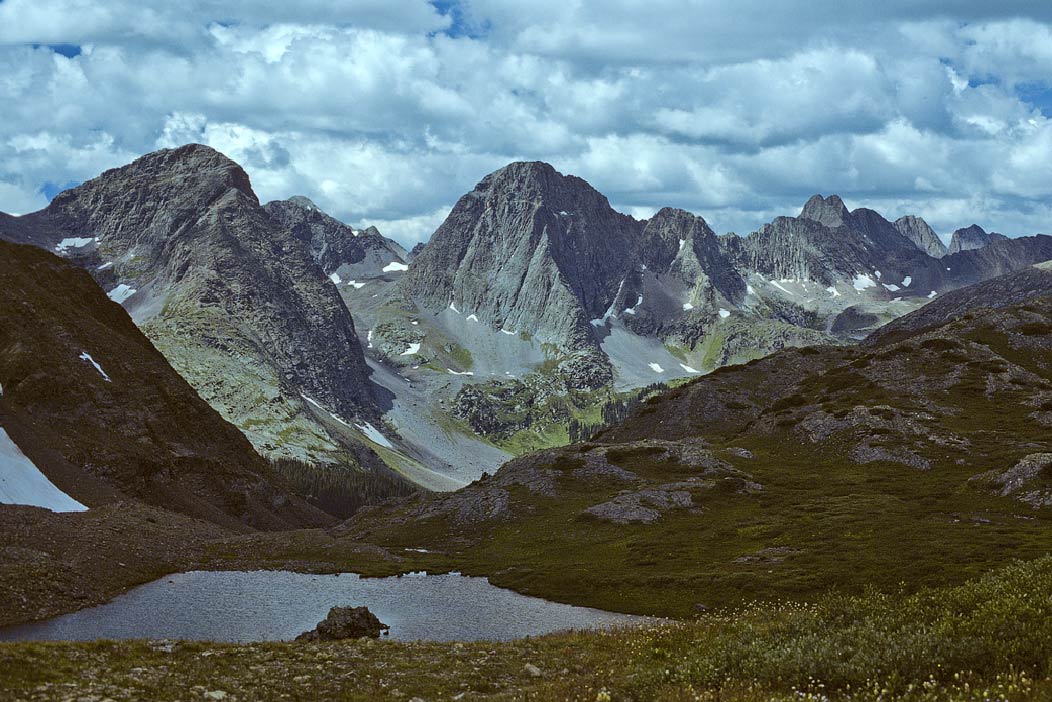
<box><xmin>0</xmin><ymin>144</ymin><xmax>378</xmax><ymax>458</ymax></box>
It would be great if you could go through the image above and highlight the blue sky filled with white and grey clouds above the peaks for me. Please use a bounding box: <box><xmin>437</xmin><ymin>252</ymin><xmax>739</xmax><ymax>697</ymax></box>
<box><xmin>0</xmin><ymin>0</ymin><xmax>1052</xmax><ymax>246</ymax></box>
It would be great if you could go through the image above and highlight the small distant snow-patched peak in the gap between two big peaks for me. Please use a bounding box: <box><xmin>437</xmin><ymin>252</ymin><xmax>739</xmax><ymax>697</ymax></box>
<box><xmin>263</xmin><ymin>196</ymin><xmax>408</xmax><ymax>285</ymax></box>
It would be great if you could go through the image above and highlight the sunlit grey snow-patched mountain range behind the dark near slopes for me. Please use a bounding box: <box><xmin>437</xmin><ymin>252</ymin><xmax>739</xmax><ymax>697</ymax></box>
<box><xmin>0</xmin><ymin>144</ymin><xmax>1052</xmax><ymax>489</ymax></box>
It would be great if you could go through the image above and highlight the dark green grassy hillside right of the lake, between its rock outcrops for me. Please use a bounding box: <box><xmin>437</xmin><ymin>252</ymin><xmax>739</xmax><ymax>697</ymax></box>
<box><xmin>334</xmin><ymin>302</ymin><xmax>1052</xmax><ymax>617</ymax></box>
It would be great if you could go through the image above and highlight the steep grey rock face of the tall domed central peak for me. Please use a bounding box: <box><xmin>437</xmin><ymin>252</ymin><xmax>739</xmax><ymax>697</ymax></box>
<box><xmin>401</xmin><ymin>162</ymin><xmax>642</xmax><ymax>362</ymax></box>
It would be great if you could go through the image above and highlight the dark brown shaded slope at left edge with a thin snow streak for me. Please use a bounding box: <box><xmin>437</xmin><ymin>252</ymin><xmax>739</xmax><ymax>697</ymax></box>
<box><xmin>0</xmin><ymin>242</ymin><xmax>328</xmax><ymax>529</ymax></box>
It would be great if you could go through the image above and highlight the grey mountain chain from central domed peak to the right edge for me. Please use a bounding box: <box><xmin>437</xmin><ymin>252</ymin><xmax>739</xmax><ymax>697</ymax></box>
<box><xmin>396</xmin><ymin>162</ymin><xmax>1052</xmax><ymax>387</ymax></box>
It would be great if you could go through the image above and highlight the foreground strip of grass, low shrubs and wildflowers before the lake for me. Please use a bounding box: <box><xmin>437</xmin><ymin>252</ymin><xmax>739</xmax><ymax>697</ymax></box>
<box><xmin>0</xmin><ymin>558</ymin><xmax>1052</xmax><ymax>701</ymax></box>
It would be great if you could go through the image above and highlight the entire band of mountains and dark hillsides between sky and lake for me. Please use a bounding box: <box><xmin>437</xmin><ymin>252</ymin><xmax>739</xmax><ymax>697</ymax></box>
<box><xmin>0</xmin><ymin>145</ymin><xmax>1052</xmax><ymax>673</ymax></box>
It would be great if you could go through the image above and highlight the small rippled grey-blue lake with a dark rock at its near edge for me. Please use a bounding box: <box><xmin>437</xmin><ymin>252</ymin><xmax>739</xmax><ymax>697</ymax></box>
<box><xmin>0</xmin><ymin>570</ymin><xmax>647</xmax><ymax>642</ymax></box>
